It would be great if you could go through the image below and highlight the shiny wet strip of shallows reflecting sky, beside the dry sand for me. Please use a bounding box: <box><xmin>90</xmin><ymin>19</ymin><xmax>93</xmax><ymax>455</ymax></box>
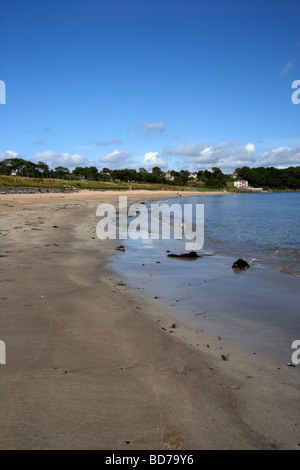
<box><xmin>109</xmin><ymin>243</ymin><xmax>298</xmax><ymax>366</ymax></box>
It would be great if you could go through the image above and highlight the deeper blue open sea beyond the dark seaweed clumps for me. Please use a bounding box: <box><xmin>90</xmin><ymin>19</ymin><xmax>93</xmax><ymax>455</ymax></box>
<box><xmin>182</xmin><ymin>193</ymin><xmax>300</xmax><ymax>275</ymax></box>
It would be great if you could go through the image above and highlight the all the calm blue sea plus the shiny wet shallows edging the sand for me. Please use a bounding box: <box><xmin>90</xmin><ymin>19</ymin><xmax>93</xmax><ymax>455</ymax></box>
<box><xmin>112</xmin><ymin>193</ymin><xmax>300</xmax><ymax>370</ymax></box>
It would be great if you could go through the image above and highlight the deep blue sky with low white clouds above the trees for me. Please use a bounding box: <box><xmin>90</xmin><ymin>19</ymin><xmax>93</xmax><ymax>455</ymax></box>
<box><xmin>0</xmin><ymin>0</ymin><xmax>300</xmax><ymax>172</ymax></box>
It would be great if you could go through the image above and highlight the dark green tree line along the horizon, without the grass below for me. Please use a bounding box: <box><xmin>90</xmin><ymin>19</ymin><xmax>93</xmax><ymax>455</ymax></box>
<box><xmin>0</xmin><ymin>158</ymin><xmax>300</xmax><ymax>189</ymax></box>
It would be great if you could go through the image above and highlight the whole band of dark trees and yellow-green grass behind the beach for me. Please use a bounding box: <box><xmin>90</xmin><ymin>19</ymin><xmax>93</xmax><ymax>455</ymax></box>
<box><xmin>0</xmin><ymin>158</ymin><xmax>300</xmax><ymax>192</ymax></box>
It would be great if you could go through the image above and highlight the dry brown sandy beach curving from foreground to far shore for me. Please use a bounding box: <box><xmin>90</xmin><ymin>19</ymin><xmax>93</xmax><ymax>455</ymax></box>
<box><xmin>0</xmin><ymin>191</ymin><xmax>300</xmax><ymax>450</ymax></box>
